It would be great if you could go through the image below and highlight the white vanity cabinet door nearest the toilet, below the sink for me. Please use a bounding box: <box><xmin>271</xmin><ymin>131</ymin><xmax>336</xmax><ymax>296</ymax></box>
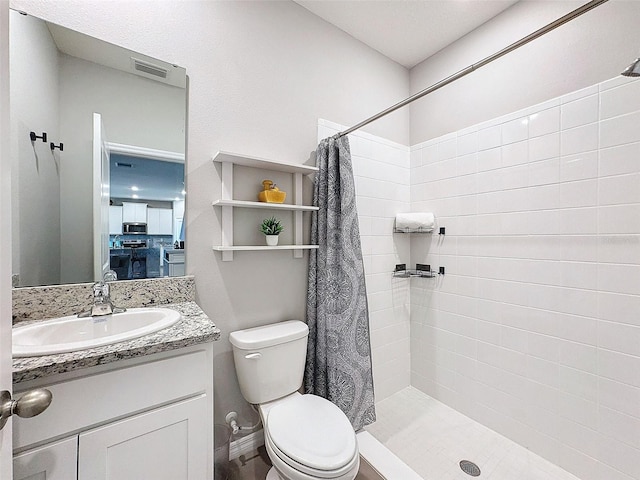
<box><xmin>78</xmin><ymin>395</ymin><xmax>211</xmax><ymax>480</ymax></box>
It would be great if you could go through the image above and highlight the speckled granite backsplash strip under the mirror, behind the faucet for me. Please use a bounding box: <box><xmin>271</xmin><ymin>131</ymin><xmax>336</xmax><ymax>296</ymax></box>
<box><xmin>12</xmin><ymin>276</ymin><xmax>196</xmax><ymax>324</ymax></box>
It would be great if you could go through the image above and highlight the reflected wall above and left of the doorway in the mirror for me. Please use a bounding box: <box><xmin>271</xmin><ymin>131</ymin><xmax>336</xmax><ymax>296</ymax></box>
<box><xmin>56</xmin><ymin>55</ymin><xmax>186</xmax><ymax>283</ymax></box>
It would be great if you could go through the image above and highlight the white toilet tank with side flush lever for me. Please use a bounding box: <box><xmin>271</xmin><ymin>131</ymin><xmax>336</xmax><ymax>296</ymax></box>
<box><xmin>229</xmin><ymin>320</ymin><xmax>309</xmax><ymax>404</ymax></box>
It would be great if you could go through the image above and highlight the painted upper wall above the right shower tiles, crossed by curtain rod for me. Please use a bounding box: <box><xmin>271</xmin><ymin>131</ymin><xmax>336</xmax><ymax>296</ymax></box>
<box><xmin>410</xmin><ymin>0</ymin><xmax>640</xmax><ymax>145</ymax></box>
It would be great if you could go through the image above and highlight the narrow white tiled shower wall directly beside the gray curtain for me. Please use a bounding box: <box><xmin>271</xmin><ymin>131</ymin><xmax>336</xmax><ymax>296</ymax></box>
<box><xmin>318</xmin><ymin>120</ymin><xmax>411</xmax><ymax>401</ymax></box>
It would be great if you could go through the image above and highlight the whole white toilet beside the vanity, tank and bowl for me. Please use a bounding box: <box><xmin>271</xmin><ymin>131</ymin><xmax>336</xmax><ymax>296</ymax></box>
<box><xmin>229</xmin><ymin>320</ymin><xmax>360</xmax><ymax>480</ymax></box>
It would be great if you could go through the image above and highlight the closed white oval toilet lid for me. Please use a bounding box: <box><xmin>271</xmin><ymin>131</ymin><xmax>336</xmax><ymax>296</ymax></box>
<box><xmin>267</xmin><ymin>395</ymin><xmax>357</xmax><ymax>470</ymax></box>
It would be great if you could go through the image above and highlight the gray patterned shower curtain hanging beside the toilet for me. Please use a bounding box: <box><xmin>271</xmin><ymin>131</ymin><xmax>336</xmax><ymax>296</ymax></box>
<box><xmin>304</xmin><ymin>136</ymin><xmax>376</xmax><ymax>430</ymax></box>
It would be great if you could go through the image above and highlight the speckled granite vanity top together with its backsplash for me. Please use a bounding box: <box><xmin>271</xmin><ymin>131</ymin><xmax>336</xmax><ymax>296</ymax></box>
<box><xmin>13</xmin><ymin>277</ymin><xmax>220</xmax><ymax>384</ymax></box>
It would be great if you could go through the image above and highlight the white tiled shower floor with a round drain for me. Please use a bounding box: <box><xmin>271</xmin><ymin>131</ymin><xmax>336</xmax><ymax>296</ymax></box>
<box><xmin>366</xmin><ymin>387</ymin><xmax>579</xmax><ymax>480</ymax></box>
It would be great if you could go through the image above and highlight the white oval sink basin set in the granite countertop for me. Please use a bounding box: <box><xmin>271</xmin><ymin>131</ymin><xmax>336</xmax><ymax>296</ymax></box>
<box><xmin>13</xmin><ymin>308</ymin><xmax>182</xmax><ymax>357</ymax></box>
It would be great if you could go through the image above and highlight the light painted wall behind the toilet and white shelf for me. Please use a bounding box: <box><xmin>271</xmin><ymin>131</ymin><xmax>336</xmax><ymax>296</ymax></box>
<box><xmin>12</xmin><ymin>0</ymin><xmax>409</xmax><ymax>421</ymax></box>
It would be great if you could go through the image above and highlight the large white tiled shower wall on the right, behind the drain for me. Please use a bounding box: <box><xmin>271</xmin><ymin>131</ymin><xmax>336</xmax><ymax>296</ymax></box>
<box><xmin>410</xmin><ymin>77</ymin><xmax>640</xmax><ymax>480</ymax></box>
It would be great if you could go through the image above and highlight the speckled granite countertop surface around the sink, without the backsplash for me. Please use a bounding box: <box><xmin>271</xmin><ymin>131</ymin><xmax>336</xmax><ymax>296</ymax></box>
<box><xmin>13</xmin><ymin>301</ymin><xmax>220</xmax><ymax>384</ymax></box>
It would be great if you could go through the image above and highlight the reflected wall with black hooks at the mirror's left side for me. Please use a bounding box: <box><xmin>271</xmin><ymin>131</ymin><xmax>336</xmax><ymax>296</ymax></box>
<box><xmin>10</xmin><ymin>12</ymin><xmax>60</xmax><ymax>285</ymax></box>
